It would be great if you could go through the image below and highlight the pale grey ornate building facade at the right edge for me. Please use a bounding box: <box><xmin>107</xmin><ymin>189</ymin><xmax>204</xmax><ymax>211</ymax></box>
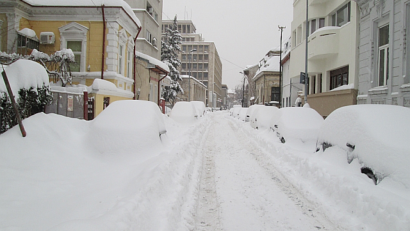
<box><xmin>357</xmin><ymin>0</ymin><xmax>410</xmax><ymax>107</ymax></box>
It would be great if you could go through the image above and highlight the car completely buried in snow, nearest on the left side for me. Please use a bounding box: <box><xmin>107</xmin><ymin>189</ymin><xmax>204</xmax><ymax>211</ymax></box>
<box><xmin>88</xmin><ymin>100</ymin><xmax>167</xmax><ymax>154</ymax></box>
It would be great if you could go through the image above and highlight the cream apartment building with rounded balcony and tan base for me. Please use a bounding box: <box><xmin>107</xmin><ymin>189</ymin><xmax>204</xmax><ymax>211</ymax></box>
<box><xmin>289</xmin><ymin>0</ymin><xmax>360</xmax><ymax>117</ymax></box>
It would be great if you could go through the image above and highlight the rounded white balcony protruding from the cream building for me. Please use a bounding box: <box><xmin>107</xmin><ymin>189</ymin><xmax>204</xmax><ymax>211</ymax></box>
<box><xmin>308</xmin><ymin>26</ymin><xmax>340</xmax><ymax>60</ymax></box>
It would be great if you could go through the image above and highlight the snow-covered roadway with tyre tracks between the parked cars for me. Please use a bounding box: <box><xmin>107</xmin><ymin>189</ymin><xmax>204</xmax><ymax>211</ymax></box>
<box><xmin>196</xmin><ymin>113</ymin><xmax>338</xmax><ymax>230</ymax></box>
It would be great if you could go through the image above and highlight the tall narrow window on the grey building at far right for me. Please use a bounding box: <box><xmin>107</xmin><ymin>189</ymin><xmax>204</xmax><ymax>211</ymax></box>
<box><xmin>378</xmin><ymin>25</ymin><xmax>389</xmax><ymax>86</ymax></box>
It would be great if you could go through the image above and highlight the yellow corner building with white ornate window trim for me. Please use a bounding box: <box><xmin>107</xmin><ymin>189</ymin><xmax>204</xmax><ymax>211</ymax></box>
<box><xmin>0</xmin><ymin>0</ymin><xmax>141</xmax><ymax>116</ymax></box>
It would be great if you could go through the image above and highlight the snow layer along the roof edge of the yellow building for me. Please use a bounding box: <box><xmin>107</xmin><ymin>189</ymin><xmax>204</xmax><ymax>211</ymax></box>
<box><xmin>23</xmin><ymin>0</ymin><xmax>141</xmax><ymax>27</ymax></box>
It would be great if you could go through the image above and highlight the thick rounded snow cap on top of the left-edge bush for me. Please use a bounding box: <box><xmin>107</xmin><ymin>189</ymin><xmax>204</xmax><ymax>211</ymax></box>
<box><xmin>0</xmin><ymin>59</ymin><xmax>49</xmax><ymax>98</ymax></box>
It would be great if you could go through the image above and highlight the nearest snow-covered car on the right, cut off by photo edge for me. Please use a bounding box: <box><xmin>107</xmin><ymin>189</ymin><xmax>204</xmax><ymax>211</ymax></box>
<box><xmin>317</xmin><ymin>105</ymin><xmax>410</xmax><ymax>188</ymax></box>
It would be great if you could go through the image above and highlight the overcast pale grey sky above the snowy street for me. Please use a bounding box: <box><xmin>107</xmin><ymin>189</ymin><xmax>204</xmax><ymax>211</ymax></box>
<box><xmin>162</xmin><ymin>0</ymin><xmax>293</xmax><ymax>89</ymax></box>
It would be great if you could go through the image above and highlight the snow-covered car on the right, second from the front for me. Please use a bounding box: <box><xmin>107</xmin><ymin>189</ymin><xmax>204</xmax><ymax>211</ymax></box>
<box><xmin>271</xmin><ymin>107</ymin><xmax>323</xmax><ymax>144</ymax></box>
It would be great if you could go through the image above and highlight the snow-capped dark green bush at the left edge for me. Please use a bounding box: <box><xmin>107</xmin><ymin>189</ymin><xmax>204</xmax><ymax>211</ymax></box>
<box><xmin>0</xmin><ymin>59</ymin><xmax>53</xmax><ymax>134</ymax></box>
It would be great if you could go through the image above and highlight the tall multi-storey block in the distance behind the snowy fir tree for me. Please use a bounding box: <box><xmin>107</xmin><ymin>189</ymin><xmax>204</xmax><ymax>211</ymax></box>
<box><xmin>162</xmin><ymin>20</ymin><xmax>223</xmax><ymax>107</ymax></box>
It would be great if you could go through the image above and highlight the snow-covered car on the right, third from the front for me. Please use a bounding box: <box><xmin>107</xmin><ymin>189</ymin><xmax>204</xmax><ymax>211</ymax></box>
<box><xmin>250</xmin><ymin>106</ymin><xmax>279</xmax><ymax>129</ymax></box>
